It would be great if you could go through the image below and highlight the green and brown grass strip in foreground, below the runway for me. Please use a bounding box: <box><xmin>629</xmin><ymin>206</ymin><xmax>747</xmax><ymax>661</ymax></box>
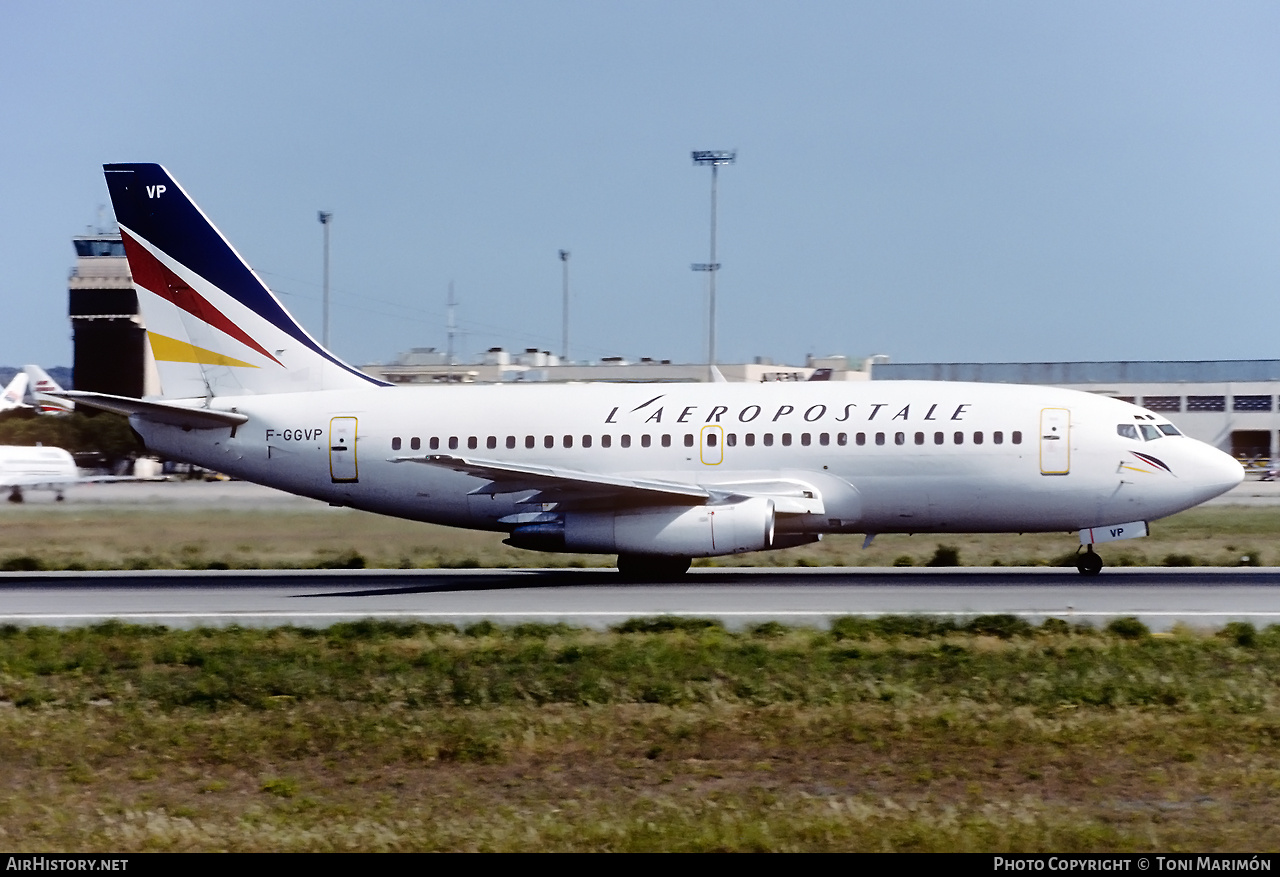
<box><xmin>0</xmin><ymin>616</ymin><xmax>1280</xmax><ymax>851</ymax></box>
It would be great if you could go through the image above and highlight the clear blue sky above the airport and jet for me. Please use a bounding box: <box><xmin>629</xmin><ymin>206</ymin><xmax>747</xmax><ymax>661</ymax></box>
<box><xmin>0</xmin><ymin>0</ymin><xmax>1280</xmax><ymax>365</ymax></box>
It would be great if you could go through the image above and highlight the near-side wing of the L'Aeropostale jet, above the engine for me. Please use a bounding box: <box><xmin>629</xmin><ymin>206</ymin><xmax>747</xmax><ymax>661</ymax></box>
<box><xmin>392</xmin><ymin>453</ymin><xmax>713</xmax><ymax>506</ymax></box>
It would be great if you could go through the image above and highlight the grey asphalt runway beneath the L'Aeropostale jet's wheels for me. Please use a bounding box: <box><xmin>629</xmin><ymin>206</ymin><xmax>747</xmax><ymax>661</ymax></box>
<box><xmin>0</xmin><ymin>567</ymin><xmax>1280</xmax><ymax>631</ymax></box>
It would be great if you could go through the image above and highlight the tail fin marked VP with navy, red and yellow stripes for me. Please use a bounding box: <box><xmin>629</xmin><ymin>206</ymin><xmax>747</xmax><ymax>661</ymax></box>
<box><xmin>102</xmin><ymin>164</ymin><xmax>384</xmax><ymax>398</ymax></box>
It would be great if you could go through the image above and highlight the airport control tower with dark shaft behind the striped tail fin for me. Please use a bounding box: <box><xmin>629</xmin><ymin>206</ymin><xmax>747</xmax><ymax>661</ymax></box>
<box><xmin>67</xmin><ymin>229</ymin><xmax>160</xmax><ymax>397</ymax></box>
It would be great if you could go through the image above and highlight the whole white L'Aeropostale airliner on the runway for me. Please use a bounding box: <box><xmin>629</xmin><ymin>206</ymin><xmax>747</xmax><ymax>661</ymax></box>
<box><xmin>63</xmin><ymin>164</ymin><xmax>1244</xmax><ymax>576</ymax></box>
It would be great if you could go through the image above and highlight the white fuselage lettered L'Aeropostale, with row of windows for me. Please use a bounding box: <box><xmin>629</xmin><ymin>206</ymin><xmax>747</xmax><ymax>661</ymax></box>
<box><xmin>133</xmin><ymin>382</ymin><xmax>1243</xmax><ymax>550</ymax></box>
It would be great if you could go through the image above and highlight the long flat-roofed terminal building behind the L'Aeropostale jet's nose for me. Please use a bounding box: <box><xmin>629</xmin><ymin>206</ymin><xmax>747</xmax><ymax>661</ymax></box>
<box><xmin>870</xmin><ymin>360</ymin><xmax>1280</xmax><ymax>465</ymax></box>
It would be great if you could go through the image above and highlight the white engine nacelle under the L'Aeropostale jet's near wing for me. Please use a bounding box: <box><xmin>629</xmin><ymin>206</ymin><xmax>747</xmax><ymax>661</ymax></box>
<box><xmin>507</xmin><ymin>497</ymin><xmax>773</xmax><ymax>557</ymax></box>
